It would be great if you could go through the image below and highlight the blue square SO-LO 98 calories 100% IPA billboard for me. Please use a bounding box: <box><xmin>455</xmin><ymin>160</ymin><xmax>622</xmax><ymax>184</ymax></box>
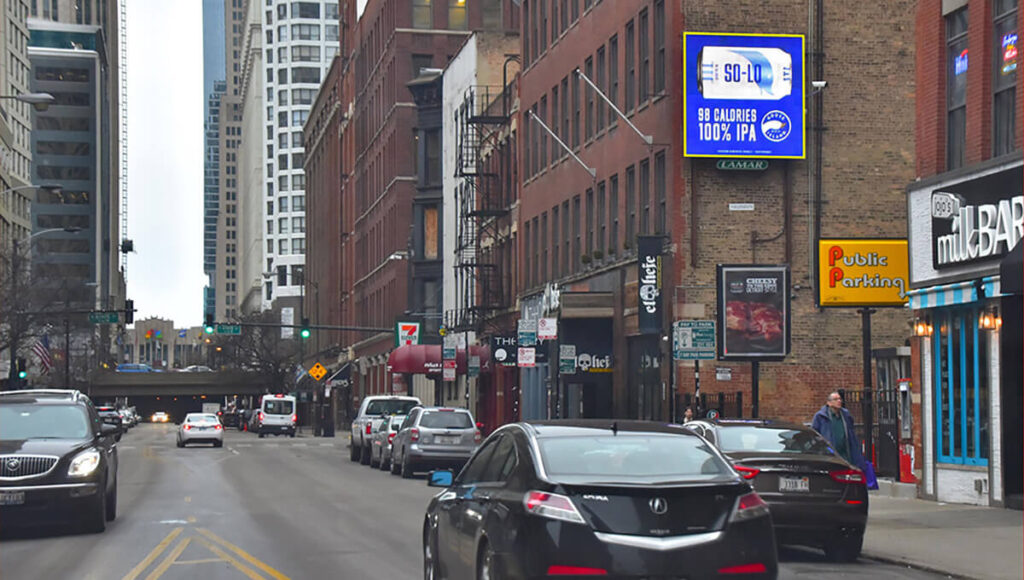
<box><xmin>683</xmin><ymin>32</ymin><xmax>806</xmax><ymax>159</ymax></box>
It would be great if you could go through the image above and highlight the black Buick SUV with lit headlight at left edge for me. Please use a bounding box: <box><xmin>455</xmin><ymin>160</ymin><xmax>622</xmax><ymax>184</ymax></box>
<box><xmin>0</xmin><ymin>389</ymin><xmax>120</xmax><ymax>532</ymax></box>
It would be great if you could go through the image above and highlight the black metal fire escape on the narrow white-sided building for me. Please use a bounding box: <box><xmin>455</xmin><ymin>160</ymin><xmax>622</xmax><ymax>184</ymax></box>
<box><xmin>447</xmin><ymin>85</ymin><xmax>514</xmax><ymax>332</ymax></box>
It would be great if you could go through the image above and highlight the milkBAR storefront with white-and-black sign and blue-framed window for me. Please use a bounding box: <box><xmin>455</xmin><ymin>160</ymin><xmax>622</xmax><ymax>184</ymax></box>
<box><xmin>907</xmin><ymin>160</ymin><xmax>1024</xmax><ymax>506</ymax></box>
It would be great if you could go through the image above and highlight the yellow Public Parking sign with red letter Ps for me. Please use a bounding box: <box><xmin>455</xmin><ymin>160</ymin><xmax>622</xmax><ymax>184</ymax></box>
<box><xmin>818</xmin><ymin>239</ymin><xmax>910</xmax><ymax>307</ymax></box>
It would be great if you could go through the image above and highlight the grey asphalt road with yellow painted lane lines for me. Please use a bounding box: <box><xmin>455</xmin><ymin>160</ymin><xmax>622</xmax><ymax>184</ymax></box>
<box><xmin>0</xmin><ymin>424</ymin><xmax>941</xmax><ymax>580</ymax></box>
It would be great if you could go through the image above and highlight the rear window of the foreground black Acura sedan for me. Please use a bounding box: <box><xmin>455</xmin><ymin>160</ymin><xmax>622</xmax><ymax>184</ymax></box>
<box><xmin>539</xmin><ymin>432</ymin><xmax>730</xmax><ymax>484</ymax></box>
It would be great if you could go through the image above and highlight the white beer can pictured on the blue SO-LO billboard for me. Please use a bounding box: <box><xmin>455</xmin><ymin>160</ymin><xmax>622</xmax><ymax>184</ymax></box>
<box><xmin>697</xmin><ymin>46</ymin><xmax>793</xmax><ymax>100</ymax></box>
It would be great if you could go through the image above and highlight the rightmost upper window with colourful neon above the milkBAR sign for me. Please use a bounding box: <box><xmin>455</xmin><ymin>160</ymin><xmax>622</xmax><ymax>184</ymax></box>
<box><xmin>992</xmin><ymin>0</ymin><xmax>1020</xmax><ymax>156</ymax></box>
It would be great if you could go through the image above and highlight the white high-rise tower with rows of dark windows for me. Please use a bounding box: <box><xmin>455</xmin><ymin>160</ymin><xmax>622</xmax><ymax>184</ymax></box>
<box><xmin>263</xmin><ymin>0</ymin><xmax>338</xmax><ymax>308</ymax></box>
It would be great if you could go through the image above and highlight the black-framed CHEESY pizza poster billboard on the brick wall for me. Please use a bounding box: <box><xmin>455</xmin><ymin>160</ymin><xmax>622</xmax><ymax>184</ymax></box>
<box><xmin>717</xmin><ymin>264</ymin><xmax>791</xmax><ymax>361</ymax></box>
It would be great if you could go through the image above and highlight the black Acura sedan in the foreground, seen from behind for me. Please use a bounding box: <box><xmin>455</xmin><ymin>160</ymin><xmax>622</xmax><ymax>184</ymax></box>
<box><xmin>423</xmin><ymin>419</ymin><xmax>778</xmax><ymax>580</ymax></box>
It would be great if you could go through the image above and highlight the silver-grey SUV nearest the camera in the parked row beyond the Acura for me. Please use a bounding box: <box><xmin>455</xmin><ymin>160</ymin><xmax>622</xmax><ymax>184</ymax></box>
<box><xmin>391</xmin><ymin>407</ymin><xmax>480</xmax><ymax>478</ymax></box>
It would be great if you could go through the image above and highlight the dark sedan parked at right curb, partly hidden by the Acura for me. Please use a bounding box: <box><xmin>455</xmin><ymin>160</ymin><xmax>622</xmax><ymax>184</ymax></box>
<box><xmin>686</xmin><ymin>420</ymin><xmax>867</xmax><ymax>562</ymax></box>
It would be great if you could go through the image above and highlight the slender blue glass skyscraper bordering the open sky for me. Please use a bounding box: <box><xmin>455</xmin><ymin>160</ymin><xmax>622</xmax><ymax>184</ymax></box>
<box><xmin>203</xmin><ymin>0</ymin><xmax>227</xmax><ymax>316</ymax></box>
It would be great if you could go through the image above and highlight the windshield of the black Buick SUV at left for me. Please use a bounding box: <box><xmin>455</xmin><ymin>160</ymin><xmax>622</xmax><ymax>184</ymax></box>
<box><xmin>0</xmin><ymin>405</ymin><xmax>92</xmax><ymax>441</ymax></box>
